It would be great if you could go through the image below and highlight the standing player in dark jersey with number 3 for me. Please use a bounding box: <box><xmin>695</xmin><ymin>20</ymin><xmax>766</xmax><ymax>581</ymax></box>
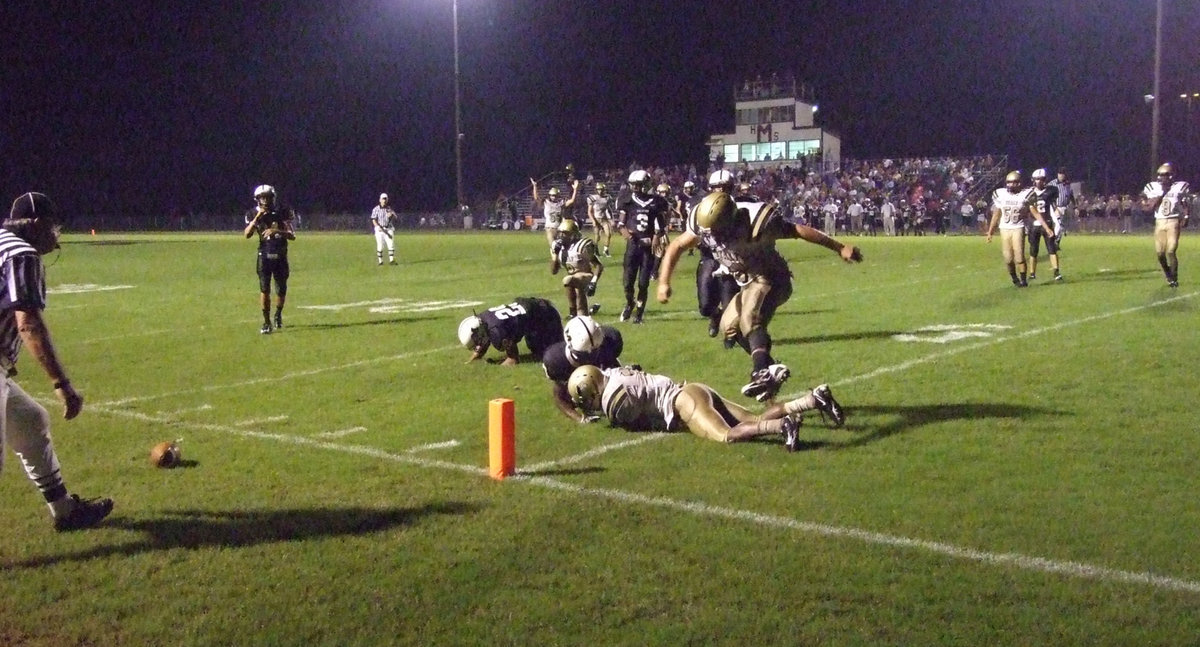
<box><xmin>617</xmin><ymin>170</ymin><xmax>670</xmax><ymax>324</ymax></box>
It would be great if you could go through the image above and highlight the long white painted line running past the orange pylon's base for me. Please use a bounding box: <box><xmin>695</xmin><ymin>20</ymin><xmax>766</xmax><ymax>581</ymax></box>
<box><xmin>84</xmin><ymin>406</ymin><xmax>1200</xmax><ymax>593</ymax></box>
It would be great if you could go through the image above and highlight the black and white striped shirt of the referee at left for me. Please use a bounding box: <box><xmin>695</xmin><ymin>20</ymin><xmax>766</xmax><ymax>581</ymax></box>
<box><xmin>0</xmin><ymin>229</ymin><xmax>46</xmax><ymax>373</ymax></box>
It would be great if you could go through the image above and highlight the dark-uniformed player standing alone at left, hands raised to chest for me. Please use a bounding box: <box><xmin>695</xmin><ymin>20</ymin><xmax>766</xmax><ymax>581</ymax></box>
<box><xmin>242</xmin><ymin>184</ymin><xmax>296</xmax><ymax>335</ymax></box>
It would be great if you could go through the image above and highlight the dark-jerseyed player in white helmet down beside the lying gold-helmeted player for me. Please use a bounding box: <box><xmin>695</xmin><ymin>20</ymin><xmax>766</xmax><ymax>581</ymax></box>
<box><xmin>541</xmin><ymin>316</ymin><xmax>625</xmax><ymax>424</ymax></box>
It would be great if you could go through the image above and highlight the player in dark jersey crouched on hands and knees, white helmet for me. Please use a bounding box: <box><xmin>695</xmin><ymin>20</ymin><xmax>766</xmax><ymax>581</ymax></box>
<box><xmin>458</xmin><ymin>296</ymin><xmax>563</xmax><ymax>366</ymax></box>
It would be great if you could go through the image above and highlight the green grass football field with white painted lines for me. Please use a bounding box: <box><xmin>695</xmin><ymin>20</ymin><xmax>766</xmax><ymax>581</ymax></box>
<box><xmin>0</xmin><ymin>232</ymin><xmax>1200</xmax><ymax>646</ymax></box>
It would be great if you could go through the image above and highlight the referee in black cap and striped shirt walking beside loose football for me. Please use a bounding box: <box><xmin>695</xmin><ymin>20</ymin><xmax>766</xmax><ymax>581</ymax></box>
<box><xmin>0</xmin><ymin>193</ymin><xmax>113</xmax><ymax>532</ymax></box>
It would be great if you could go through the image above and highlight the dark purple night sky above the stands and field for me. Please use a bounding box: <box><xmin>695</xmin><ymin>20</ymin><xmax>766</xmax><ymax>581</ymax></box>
<box><xmin>0</xmin><ymin>0</ymin><xmax>1200</xmax><ymax>216</ymax></box>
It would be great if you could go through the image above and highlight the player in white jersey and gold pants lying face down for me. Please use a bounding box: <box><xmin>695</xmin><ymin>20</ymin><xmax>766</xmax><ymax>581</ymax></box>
<box><xmin>566</xmin><ymin>366</ymin><xmax>846</xmax><ymax>451</ymax></box>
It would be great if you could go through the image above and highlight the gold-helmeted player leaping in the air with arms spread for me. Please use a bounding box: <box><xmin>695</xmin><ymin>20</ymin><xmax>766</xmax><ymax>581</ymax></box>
<box><xmin>658</xmin><ymin>175</ymin><xmax>863</xmax><ymax>402</ymax></box>
